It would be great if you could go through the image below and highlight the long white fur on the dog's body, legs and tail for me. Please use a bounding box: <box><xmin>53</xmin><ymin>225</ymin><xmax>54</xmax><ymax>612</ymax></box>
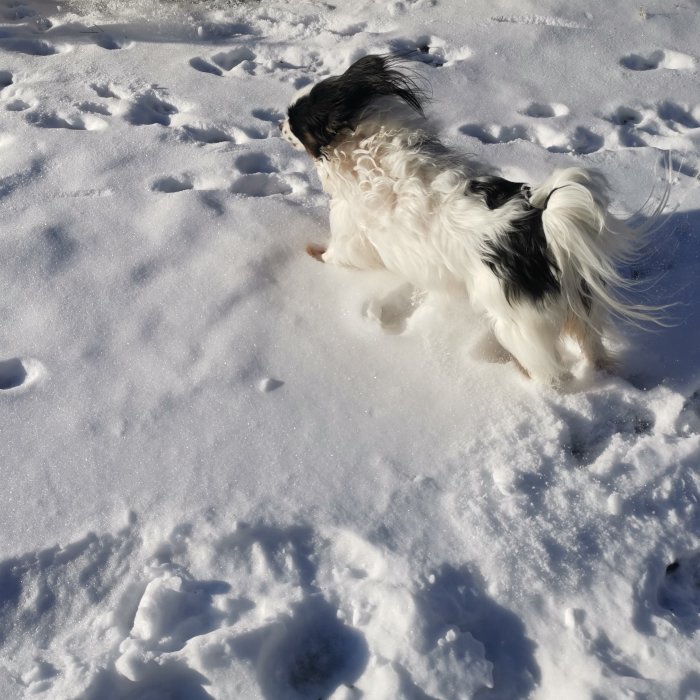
<box><xmin>283</xmin><ymin>110</ymin><xmax>665</xmax><ymax>384</ymax></box>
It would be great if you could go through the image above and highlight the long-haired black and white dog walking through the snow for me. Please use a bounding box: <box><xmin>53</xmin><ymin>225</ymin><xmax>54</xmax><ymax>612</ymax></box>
<box><xmin>280</xmin><ymin>56</ymin><xmax>665</xmax><ymax>384</ymax></box>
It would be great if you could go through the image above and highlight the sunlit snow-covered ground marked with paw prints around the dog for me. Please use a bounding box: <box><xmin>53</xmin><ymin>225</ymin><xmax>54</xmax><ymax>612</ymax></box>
<box><xmin>0</xmin><ymin>0</ymin><xmax>700</xmax><ymax>700</ymax></box>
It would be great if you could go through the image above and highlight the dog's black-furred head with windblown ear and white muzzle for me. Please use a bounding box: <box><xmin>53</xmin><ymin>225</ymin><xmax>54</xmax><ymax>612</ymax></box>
<box><xmin>280</xmin><ymin>56</ymin><xmax>423</xmax><ymax>158</ymax></box>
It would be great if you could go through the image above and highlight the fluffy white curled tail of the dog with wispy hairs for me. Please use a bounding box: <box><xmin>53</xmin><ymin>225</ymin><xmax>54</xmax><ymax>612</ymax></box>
<box><xmin>530</xmin><ymin>168</ymin><xmax>670</xmax><ymax>325</ymax></box>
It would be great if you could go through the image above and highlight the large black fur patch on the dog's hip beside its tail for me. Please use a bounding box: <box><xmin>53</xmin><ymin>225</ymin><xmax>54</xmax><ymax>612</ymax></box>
<box><xmin>482</xmin><ymin>207</ymin><xmax>561</xmax><ymax>305</ymax></box>
